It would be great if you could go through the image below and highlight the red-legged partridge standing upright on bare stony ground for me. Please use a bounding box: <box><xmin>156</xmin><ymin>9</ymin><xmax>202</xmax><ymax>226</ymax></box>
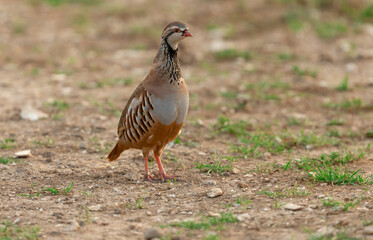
<box><xmin>107</xmin><ymin>22</ymin><xmax>192</xmax><ymax>181</ymax></box>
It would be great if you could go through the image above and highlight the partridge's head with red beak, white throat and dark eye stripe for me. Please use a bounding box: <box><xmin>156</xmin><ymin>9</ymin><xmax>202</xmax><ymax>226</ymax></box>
<box><xmin>161</xmin><ymin>22</ymin><xmax>192</xmax><ymax>50</ymax></box>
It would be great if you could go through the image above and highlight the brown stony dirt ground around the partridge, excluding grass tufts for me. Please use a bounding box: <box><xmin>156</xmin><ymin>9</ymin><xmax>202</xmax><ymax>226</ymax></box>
<box><xmin>0</xmin><ymin>0</ymin><xmax>373</xmax><ymax>239</ymax></box>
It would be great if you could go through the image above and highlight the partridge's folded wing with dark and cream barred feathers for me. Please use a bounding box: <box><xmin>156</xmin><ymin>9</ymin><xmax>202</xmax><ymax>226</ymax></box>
<box><xmin>118</xmin><ymin>84</ymin><xmax>155</xmax><ymax>145</ymax></box>
